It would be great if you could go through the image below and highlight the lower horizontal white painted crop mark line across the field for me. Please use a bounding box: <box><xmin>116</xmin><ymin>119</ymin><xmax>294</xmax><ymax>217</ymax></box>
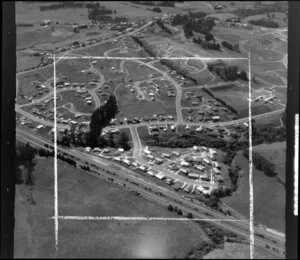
<box><xmin>51</xmin><ymin>216</ymin><xmax>247</xmax><ymax>222</ymax></box>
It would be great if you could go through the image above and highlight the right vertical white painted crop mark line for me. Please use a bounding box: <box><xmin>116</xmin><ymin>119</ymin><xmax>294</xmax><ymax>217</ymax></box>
<box><xmin>248</xmin><ymin>52</ymin><xmax>254</xmax><ymax>259</ymax></box>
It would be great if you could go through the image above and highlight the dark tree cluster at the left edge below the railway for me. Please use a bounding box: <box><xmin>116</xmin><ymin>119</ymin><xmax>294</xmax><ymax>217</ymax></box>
<box><xmin>15</xmin><ymin>142</ymin><xmax>37</xmax><ymax>186</ymax></box>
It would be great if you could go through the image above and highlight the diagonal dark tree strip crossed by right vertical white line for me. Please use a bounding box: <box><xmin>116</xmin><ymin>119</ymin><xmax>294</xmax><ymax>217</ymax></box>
<box><xmin>243</xmin><ymin>149</ymin><xmax>277</xmax><ymax>177</ymax></box>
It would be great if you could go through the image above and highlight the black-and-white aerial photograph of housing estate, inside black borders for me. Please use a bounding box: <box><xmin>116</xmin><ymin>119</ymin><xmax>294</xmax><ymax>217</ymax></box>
<box><xmin>14</xmin><ymin>1</ymin><xmax>288</xmax><ymax>259</ymax></box>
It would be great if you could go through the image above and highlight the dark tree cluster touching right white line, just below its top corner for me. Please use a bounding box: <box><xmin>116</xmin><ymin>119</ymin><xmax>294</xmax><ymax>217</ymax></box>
<box><xmin>207</xmin><ymin>64</ymin><xmax>249</xmax><ymax>81</ymax></box>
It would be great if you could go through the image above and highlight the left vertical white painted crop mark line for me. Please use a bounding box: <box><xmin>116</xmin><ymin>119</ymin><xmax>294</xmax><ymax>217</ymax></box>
<box><xmin>53</xmin><ymin>53</ymin><xmax>58</xmax><ymax>255</ymax></box>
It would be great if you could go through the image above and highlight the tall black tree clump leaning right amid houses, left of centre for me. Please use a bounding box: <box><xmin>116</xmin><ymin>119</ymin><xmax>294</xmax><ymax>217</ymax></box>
<box><xmin>88</xmin><ymin>95</ymin><xmax>118</xmax><ymax>148</ymax></box>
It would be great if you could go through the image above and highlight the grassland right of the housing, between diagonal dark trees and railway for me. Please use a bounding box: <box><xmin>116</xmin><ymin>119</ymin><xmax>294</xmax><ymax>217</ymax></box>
<box><xmin>222</xmin><ymin>152</ymin><xmax>285</xmax><ymax>232</ymax></box>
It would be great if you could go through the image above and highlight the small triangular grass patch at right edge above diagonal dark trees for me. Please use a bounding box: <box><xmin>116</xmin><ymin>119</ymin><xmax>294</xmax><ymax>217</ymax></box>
<box><xmin>253</xmin><ymin>142</ymin><xmax>286</xmax><ymax>182</ymax></box>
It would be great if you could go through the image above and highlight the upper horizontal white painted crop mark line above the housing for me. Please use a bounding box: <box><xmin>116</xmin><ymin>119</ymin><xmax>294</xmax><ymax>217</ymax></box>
<box><xmin>48</xmin><ymin>55</ymin><xmax>248</xmax><ymax>61</ymax></box>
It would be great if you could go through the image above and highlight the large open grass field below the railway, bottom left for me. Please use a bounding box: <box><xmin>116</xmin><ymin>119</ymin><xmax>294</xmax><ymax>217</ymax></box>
<box><xmin>14</xmin><ymin>158</ymin><xmax>207</xmax><ymax>258</ymax></box>
